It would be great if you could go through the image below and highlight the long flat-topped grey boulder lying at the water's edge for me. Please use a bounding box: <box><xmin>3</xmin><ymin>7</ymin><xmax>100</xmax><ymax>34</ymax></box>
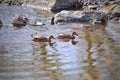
<box><xmin>54</xmin><ymin>11</ymin><xmax>107</xmax><ymax>24</ymax></box>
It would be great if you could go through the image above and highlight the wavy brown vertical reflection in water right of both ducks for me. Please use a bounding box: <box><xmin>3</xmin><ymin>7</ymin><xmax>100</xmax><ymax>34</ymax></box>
<box><xmin>83</xmin><ymin>30</ymin><xmax>101</xmax><ymax>80</ymax></box>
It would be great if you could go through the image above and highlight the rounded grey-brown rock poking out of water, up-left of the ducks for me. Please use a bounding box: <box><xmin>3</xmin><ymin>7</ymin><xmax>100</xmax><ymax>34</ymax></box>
<box><xmin>12</xmin><ymin>15</ymin><xmax>29</xmax><ymax>27</ymax></box>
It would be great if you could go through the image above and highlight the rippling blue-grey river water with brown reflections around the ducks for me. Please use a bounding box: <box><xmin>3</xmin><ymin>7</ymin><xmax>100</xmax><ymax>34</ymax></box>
<box><xmin>0</xmin><ymin>5</ymin><xmax>120</xmax><ymax>80</ymax></box>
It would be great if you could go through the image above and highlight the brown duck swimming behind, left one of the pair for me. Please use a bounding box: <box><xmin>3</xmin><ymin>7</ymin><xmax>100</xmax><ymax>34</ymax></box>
<box><xmin>32</xmin><ymin>36</ymin><xmax>55</xmax><ymax>42</ymax></box>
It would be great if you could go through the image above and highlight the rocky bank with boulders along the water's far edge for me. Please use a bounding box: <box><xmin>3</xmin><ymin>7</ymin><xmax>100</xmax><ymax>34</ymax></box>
<box><xmin>0</xmin><ymin>0</ymin><xmax>120</xmax><ymax>24</ymax></box>
